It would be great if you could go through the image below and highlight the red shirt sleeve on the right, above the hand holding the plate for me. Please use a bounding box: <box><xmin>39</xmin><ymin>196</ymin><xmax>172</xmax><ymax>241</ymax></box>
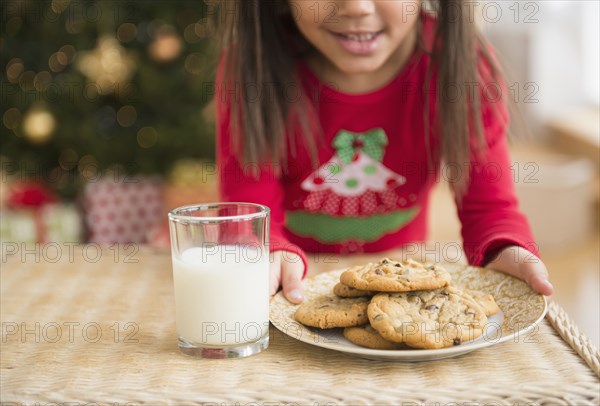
<box><xmin>456</xmin><ymin>70</ymin><xmax>539</xmax><ymax>266</ymax></box>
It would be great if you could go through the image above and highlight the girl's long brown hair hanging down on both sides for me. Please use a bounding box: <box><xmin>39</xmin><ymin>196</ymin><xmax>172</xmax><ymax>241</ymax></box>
<box><xmin>220</xmin><ymin>0</ymin><xmax>499</xmax><ymax>197</ymax></box>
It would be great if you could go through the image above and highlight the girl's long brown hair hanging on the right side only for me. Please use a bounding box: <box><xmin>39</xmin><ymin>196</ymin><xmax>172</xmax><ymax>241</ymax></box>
<box><xmin>424</xmin><ymin>0</ymin><xmax>499</xmax><ymax>201</ymax></box>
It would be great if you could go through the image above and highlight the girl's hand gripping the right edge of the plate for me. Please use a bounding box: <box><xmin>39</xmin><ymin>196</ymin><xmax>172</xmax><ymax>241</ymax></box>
<box><xmin>486</xmin><ymin>245</ymin><xmax>554</xmax><ymax>296</ymax></box>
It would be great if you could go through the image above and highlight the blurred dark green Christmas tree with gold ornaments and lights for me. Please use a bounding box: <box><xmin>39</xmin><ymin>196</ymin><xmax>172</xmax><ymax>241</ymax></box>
<box><xmin>0</xmin><ymin>0</ymin><xmax>215</xmax><ymax>197</ymax></box>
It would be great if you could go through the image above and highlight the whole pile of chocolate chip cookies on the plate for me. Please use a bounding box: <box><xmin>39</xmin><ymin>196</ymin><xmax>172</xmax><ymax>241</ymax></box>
<box><xmin>295</xmin><ymin>258</ymin><xmax>499</xmax><ymax>350</ymax></box>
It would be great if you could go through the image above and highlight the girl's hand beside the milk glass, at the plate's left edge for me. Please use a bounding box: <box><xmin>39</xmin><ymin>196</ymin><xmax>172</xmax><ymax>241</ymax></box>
<box><xmin>269</xmin><ymin>251</ymin><xmax>304</xmax><ymax>304</ymax></box>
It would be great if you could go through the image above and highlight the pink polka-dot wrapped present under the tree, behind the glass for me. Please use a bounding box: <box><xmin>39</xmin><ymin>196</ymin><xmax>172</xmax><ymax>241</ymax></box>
<box><xmin>83</xmin><ymin>176</ymin><xmax>163</xmax><ymax>244</ymax></box>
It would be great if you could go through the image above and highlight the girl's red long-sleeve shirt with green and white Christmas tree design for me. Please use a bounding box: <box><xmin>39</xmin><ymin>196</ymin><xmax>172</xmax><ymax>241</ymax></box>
<box><xmin>217</xmin><ymin>16</ymin><xmax>537</xmax><ymax>276</ymax></box>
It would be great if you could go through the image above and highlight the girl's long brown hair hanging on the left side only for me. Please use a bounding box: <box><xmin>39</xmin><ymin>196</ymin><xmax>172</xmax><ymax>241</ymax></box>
<box><xmin>220</xmin><ymin>0</ymin><xmax>317</xmax><ymax>171</ymax></box>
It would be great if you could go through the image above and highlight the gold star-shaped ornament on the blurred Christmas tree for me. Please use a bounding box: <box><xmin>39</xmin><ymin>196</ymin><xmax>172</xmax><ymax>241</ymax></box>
<box><xmin>77</xmin><ymin>36</ymin><xmax>135</xmax><ymax>94</ymax></box>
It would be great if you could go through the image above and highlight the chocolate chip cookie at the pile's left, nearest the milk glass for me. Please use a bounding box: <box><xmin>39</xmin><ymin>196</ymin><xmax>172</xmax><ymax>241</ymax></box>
<box><xmin>294</xmin><ymin>295</ymin><xmax>370</xmax><ymax>328</ymax></box>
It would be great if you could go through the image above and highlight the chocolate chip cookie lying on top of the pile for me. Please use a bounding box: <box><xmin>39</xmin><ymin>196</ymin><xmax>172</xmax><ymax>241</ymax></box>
<box><xmin>340</xmin><ymin>258</ymin><xmax>451</xmax><ymax>292</ymax></box>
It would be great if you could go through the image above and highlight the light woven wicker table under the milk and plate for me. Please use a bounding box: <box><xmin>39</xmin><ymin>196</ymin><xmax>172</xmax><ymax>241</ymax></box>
<box><xmin>0</xmin><ymin>245</ymin><xmax>600</xmax><ymax>406</ymax></box>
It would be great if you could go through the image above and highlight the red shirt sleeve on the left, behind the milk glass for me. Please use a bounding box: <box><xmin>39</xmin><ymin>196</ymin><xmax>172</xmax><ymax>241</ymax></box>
<box><xmin>215</xmin><ymin>64</ymin><xmax>308</xmax><ymax>278</ymax></box>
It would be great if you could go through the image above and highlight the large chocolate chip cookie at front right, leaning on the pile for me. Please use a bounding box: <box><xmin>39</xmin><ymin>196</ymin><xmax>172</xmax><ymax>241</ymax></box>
<box><xmin>368</xmin><ymin>286</ymin><xmax>487</xmax><ymax>348</ymax></box>
